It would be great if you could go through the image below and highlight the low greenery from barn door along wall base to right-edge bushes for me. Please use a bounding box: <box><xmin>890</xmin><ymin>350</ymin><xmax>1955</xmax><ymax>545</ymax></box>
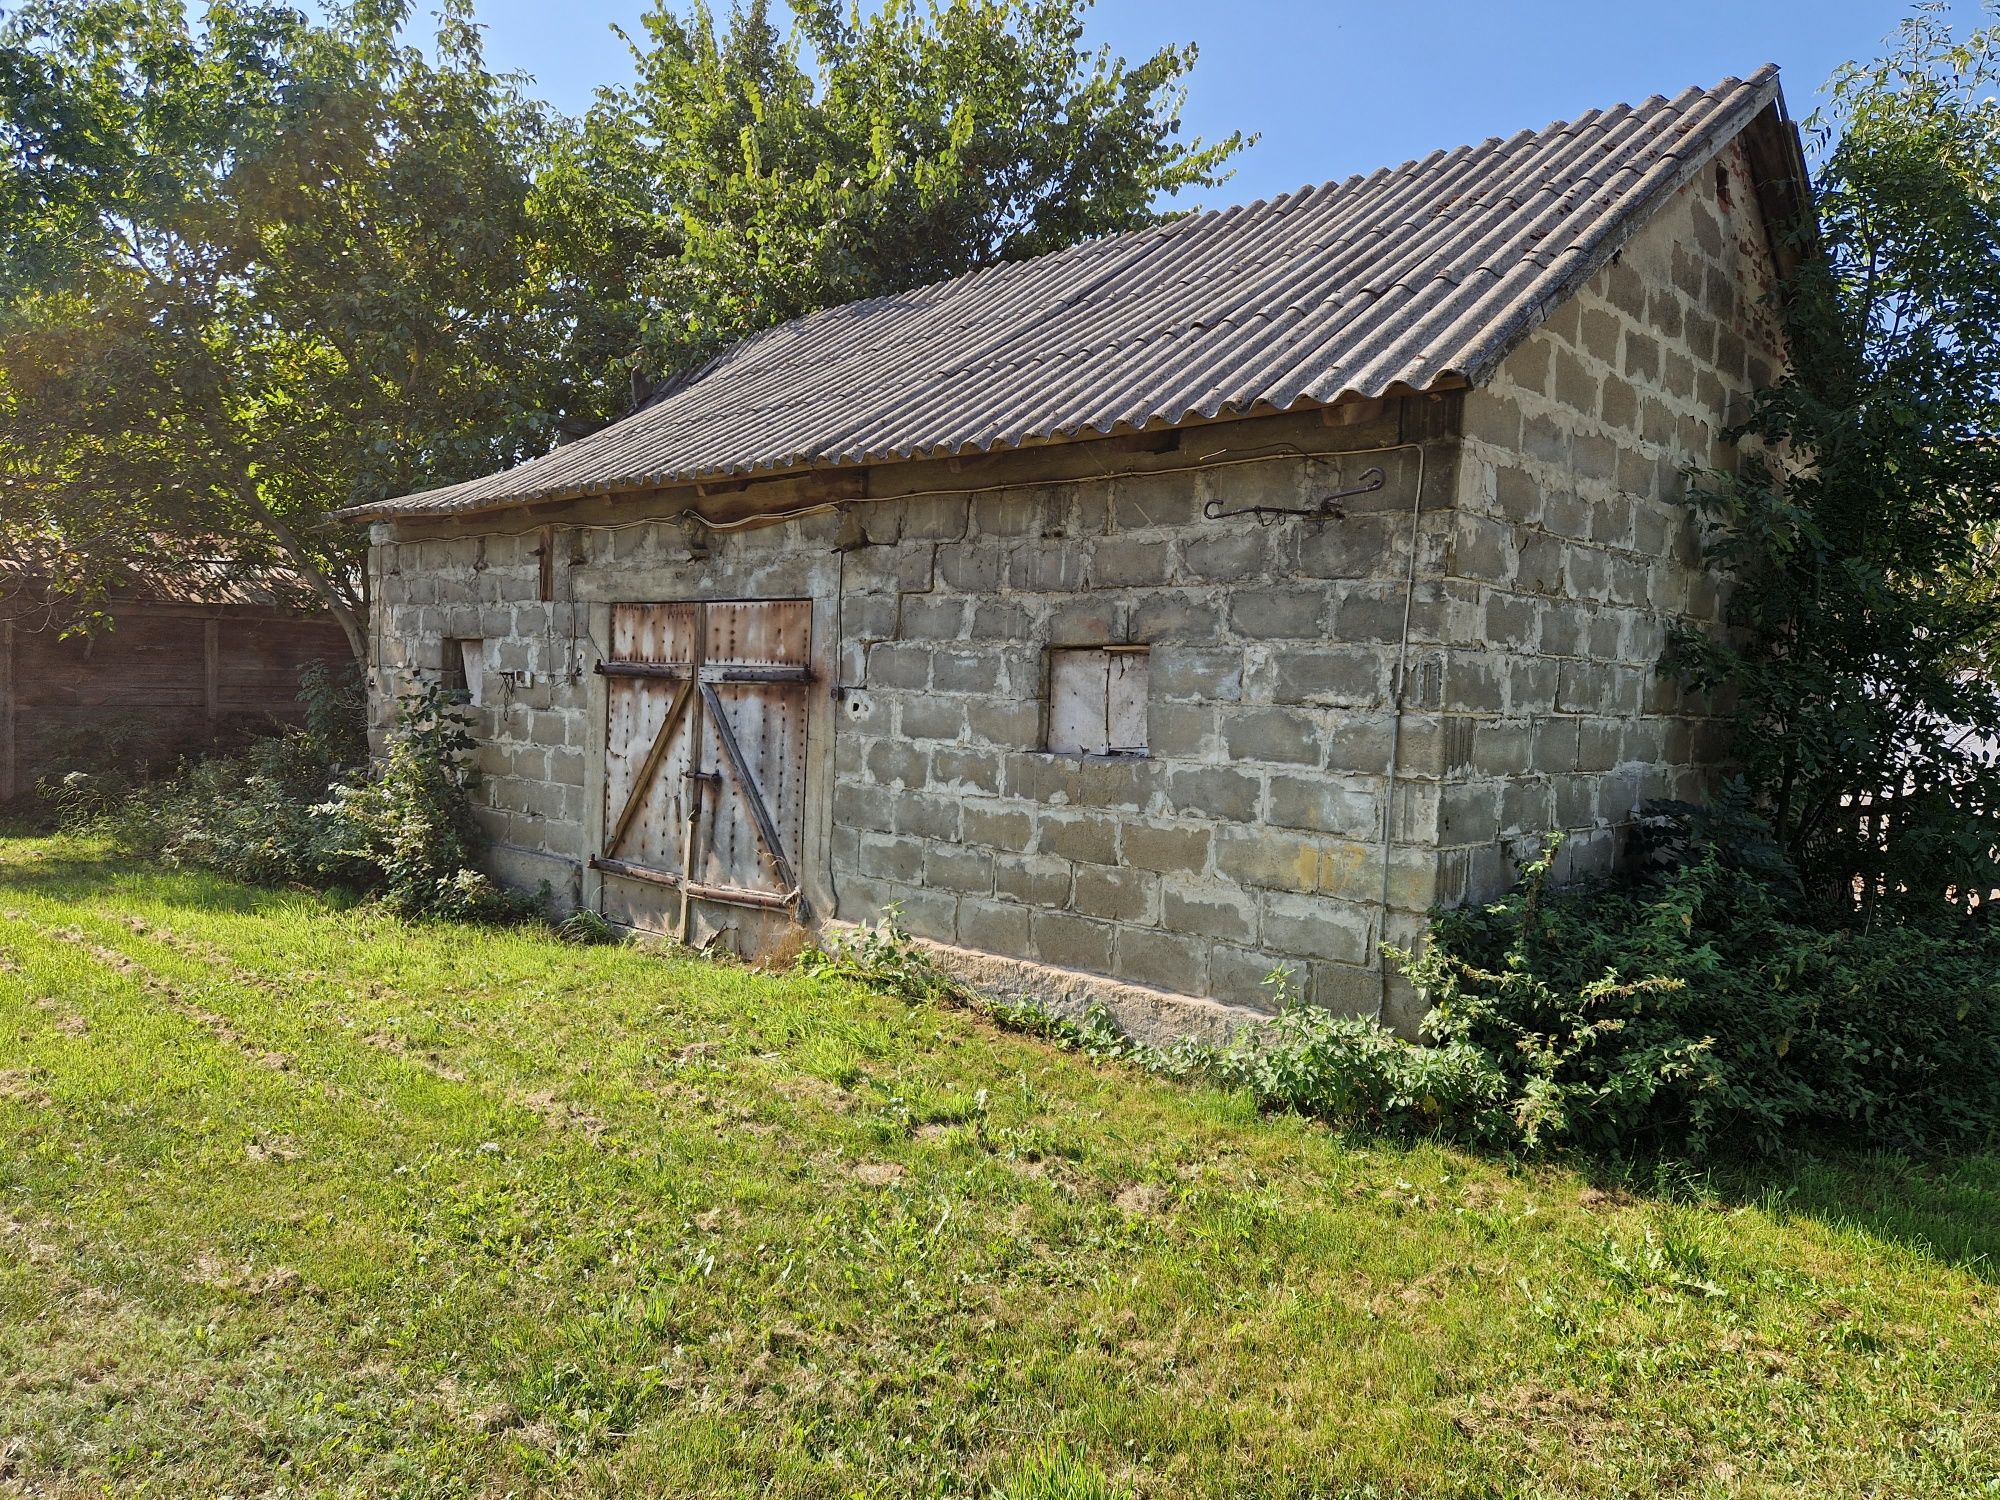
<box><xmin>802</xmin><ymin>840</ymin><xmax>2000</xmax><ymax>1158</ymax></box>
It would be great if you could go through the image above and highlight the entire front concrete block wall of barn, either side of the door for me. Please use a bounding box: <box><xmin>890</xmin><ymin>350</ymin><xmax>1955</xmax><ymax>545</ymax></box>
<box><xmin>372</xmin><ymin>398</ymin><xmax>1456</xmax><ymax>1020</ymax></box>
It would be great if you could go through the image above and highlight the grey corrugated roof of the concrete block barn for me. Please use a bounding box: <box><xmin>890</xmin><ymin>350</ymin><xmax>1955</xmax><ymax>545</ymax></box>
<box><xmin>348</xmin><ymin>66</ymin><xmax>1778</xmax><ymax>520</ymax></box>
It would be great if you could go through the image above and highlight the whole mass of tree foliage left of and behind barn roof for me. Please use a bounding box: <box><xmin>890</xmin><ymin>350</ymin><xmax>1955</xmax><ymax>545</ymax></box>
<box><xmin>0</xmin><ymin>0</ymin><xmax>1240</xmax><ymax>652</ymax></box>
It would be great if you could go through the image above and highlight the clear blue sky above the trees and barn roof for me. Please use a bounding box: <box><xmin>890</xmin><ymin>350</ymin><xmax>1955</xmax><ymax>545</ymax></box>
<box><xmin>464</xmin><ymin>0</ymin><xmax>1936</xmax><ymax>204</ymax></box>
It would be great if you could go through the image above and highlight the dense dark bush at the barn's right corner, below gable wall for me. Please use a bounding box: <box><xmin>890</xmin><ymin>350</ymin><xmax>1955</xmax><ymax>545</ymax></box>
<box><xmin>1400</xmin><ymin>812</ymin><xmax>2000</xmax><ymax>1154</ymax></box>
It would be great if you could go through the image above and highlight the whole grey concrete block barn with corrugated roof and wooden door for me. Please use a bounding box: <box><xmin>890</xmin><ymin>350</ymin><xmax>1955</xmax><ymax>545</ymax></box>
<box><xmin>350</xmin><ymin>68</ymin><xmax>1804</xmax><ymax>1034</ymax></box>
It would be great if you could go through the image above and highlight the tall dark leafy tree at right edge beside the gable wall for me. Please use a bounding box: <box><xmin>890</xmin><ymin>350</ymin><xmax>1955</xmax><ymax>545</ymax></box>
<box><xmin>1672</xmin><ymin>6</ymin><xmax>2000</xmax><ymax>914</ymax></box>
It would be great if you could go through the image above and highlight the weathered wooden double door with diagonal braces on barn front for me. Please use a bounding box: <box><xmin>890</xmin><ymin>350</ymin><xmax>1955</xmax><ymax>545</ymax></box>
<box><xmin>592</xmin><ymin>600</ymin><xmax>812</xmax><ymax>938</ymax></box>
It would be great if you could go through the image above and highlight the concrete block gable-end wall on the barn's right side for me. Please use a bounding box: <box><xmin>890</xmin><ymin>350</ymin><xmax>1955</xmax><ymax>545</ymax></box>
<box><xmin>1434</xmin><ymin>146</ymin><xmax>1784</xmax><ymax>900</ymax></box>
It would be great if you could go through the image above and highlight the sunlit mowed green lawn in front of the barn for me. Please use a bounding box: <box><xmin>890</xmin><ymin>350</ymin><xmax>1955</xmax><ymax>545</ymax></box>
<box><xmin>0</xmin><ymin>840</ymin><xmax>2000</xmax><ymax>1500</ymax></box>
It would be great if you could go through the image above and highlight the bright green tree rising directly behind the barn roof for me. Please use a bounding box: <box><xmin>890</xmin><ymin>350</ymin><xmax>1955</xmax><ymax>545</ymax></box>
<box><xmin>538</xmin><ymin>0</ymin><xmax>1246</xmax><ymax>420</ymax></box>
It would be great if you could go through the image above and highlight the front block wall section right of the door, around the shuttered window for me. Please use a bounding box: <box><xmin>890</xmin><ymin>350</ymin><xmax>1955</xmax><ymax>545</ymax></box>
<box><xmin>832</xmin><ymin>402</ymin><xmax>1456</xmax><ymax>1032</ymax></box>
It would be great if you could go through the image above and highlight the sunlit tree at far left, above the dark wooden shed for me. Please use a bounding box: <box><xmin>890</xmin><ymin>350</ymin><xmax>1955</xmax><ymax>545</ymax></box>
<box><xmin>0</xmin><ymin>0</ymin><xmax>554</xmax><ymax>654</ymax></box>
